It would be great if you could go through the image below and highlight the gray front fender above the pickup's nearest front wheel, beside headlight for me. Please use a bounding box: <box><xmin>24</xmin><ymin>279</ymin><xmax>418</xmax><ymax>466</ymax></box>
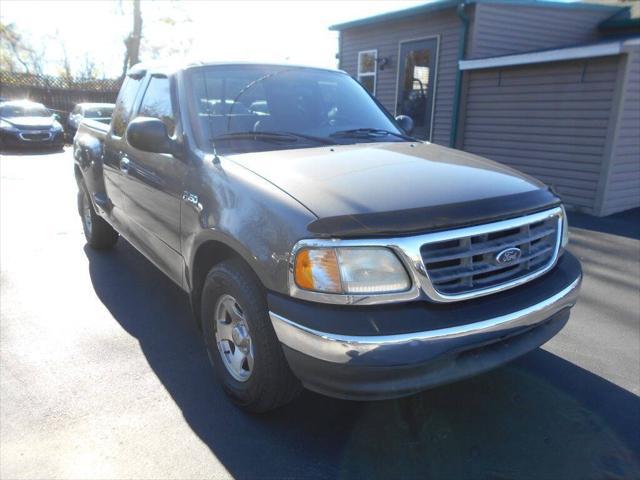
<box><xmin>181</xmin><ymin>158</ymin><xmax>317</xmax><ymax>294</ymax></box>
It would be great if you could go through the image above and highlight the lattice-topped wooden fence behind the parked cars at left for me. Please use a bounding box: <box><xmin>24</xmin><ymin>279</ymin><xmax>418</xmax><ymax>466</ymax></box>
<box><xmin>0</xmin><ymin>71</ymin><xmax>121</xmax><ymax>117</ymax></box>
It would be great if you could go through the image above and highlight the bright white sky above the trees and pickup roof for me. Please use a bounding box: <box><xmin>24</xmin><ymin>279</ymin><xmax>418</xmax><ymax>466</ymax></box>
<box><xmin>0</xmin><ymin>0</ymin><xmax>428</xmax><ymax>77</ymax></box>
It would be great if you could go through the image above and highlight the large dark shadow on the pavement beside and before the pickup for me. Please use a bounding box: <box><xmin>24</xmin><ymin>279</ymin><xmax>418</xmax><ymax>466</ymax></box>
<box><xmin>85</xmin><ymin>244</ymin><xmax>640</xmax><ymax>479</ymax></box>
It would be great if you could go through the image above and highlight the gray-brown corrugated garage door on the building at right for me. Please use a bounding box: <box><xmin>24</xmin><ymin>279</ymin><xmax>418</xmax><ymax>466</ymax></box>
<box><xmin>463</xmin><ymin>56</ymin><xmax>619</xmax><ymax>213</ymax></box>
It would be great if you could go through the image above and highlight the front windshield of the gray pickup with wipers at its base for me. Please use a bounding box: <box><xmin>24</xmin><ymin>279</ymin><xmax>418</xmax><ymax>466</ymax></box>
<box><xmin>189</xmin><ymin>65</ymin><xmax>407</xmax><ymax>153</ymax></box>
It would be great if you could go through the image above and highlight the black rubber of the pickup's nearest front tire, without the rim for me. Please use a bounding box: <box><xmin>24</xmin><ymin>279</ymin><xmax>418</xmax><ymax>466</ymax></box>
<box><xmin>201</xmin><ymin>259</ymin><xmax>302</xmax><ymax>413</ymax></box>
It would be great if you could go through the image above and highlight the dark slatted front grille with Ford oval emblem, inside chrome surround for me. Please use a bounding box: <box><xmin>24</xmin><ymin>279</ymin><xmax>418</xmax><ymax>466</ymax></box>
<box><xmin>420</xmin><ymin>216</ymin><xmax>561</xmax><ymax>295</ymax></box>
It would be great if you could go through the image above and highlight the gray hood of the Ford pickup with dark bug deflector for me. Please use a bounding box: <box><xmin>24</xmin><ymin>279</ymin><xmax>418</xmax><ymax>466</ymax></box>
<box><xmin>230</xmin><ymin>142</ymin><xmax>559</xmax><ymax>236</ymax></box>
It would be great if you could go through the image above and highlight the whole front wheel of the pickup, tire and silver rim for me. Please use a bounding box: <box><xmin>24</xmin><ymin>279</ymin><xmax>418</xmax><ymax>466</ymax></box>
<box><xmin>201</xmin><ymin>259</ymin><xmax>302</xmax><ymax>413</ymax></box>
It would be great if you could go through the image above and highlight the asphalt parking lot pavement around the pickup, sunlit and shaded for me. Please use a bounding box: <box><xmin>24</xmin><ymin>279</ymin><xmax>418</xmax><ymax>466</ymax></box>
<box><xmin>0</xmin><ymin>150</ymin><xmax>640</xmax><ymax>479</ymax></box>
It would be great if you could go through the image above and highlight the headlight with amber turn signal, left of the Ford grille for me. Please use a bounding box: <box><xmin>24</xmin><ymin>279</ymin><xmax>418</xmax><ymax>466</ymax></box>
<box><xmin>294</xmin><ymin>247</ymin><xmax>411</xmax><ymax>295</ymax></box>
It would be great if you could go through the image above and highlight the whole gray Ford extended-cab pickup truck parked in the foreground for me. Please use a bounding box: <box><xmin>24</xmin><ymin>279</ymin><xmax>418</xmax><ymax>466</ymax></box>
<box><xmin>74</xmin><ymin>63</ymin><xmax>582</xmax><ymax>412</ymax></box>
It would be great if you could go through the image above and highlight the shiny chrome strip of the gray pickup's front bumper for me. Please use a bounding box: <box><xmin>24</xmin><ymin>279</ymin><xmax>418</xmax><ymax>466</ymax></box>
<box><xmin>269</xmin><ymin>277</ymin><xmax>582</xmax><ymax>363</ymax></box>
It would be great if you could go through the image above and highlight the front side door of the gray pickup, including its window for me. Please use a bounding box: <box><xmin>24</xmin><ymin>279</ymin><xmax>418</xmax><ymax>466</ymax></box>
<box><xmin>118</xmin><ymin>75</ymin><xmax>187</xmax><ymax>283</ymax></box>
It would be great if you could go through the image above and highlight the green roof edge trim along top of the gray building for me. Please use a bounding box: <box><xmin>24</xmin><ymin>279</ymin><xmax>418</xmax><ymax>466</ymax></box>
<box><xmin>329</xmin><ymin>0</ymin><xmax>629</xmax><ymax>30</ymax></box>
